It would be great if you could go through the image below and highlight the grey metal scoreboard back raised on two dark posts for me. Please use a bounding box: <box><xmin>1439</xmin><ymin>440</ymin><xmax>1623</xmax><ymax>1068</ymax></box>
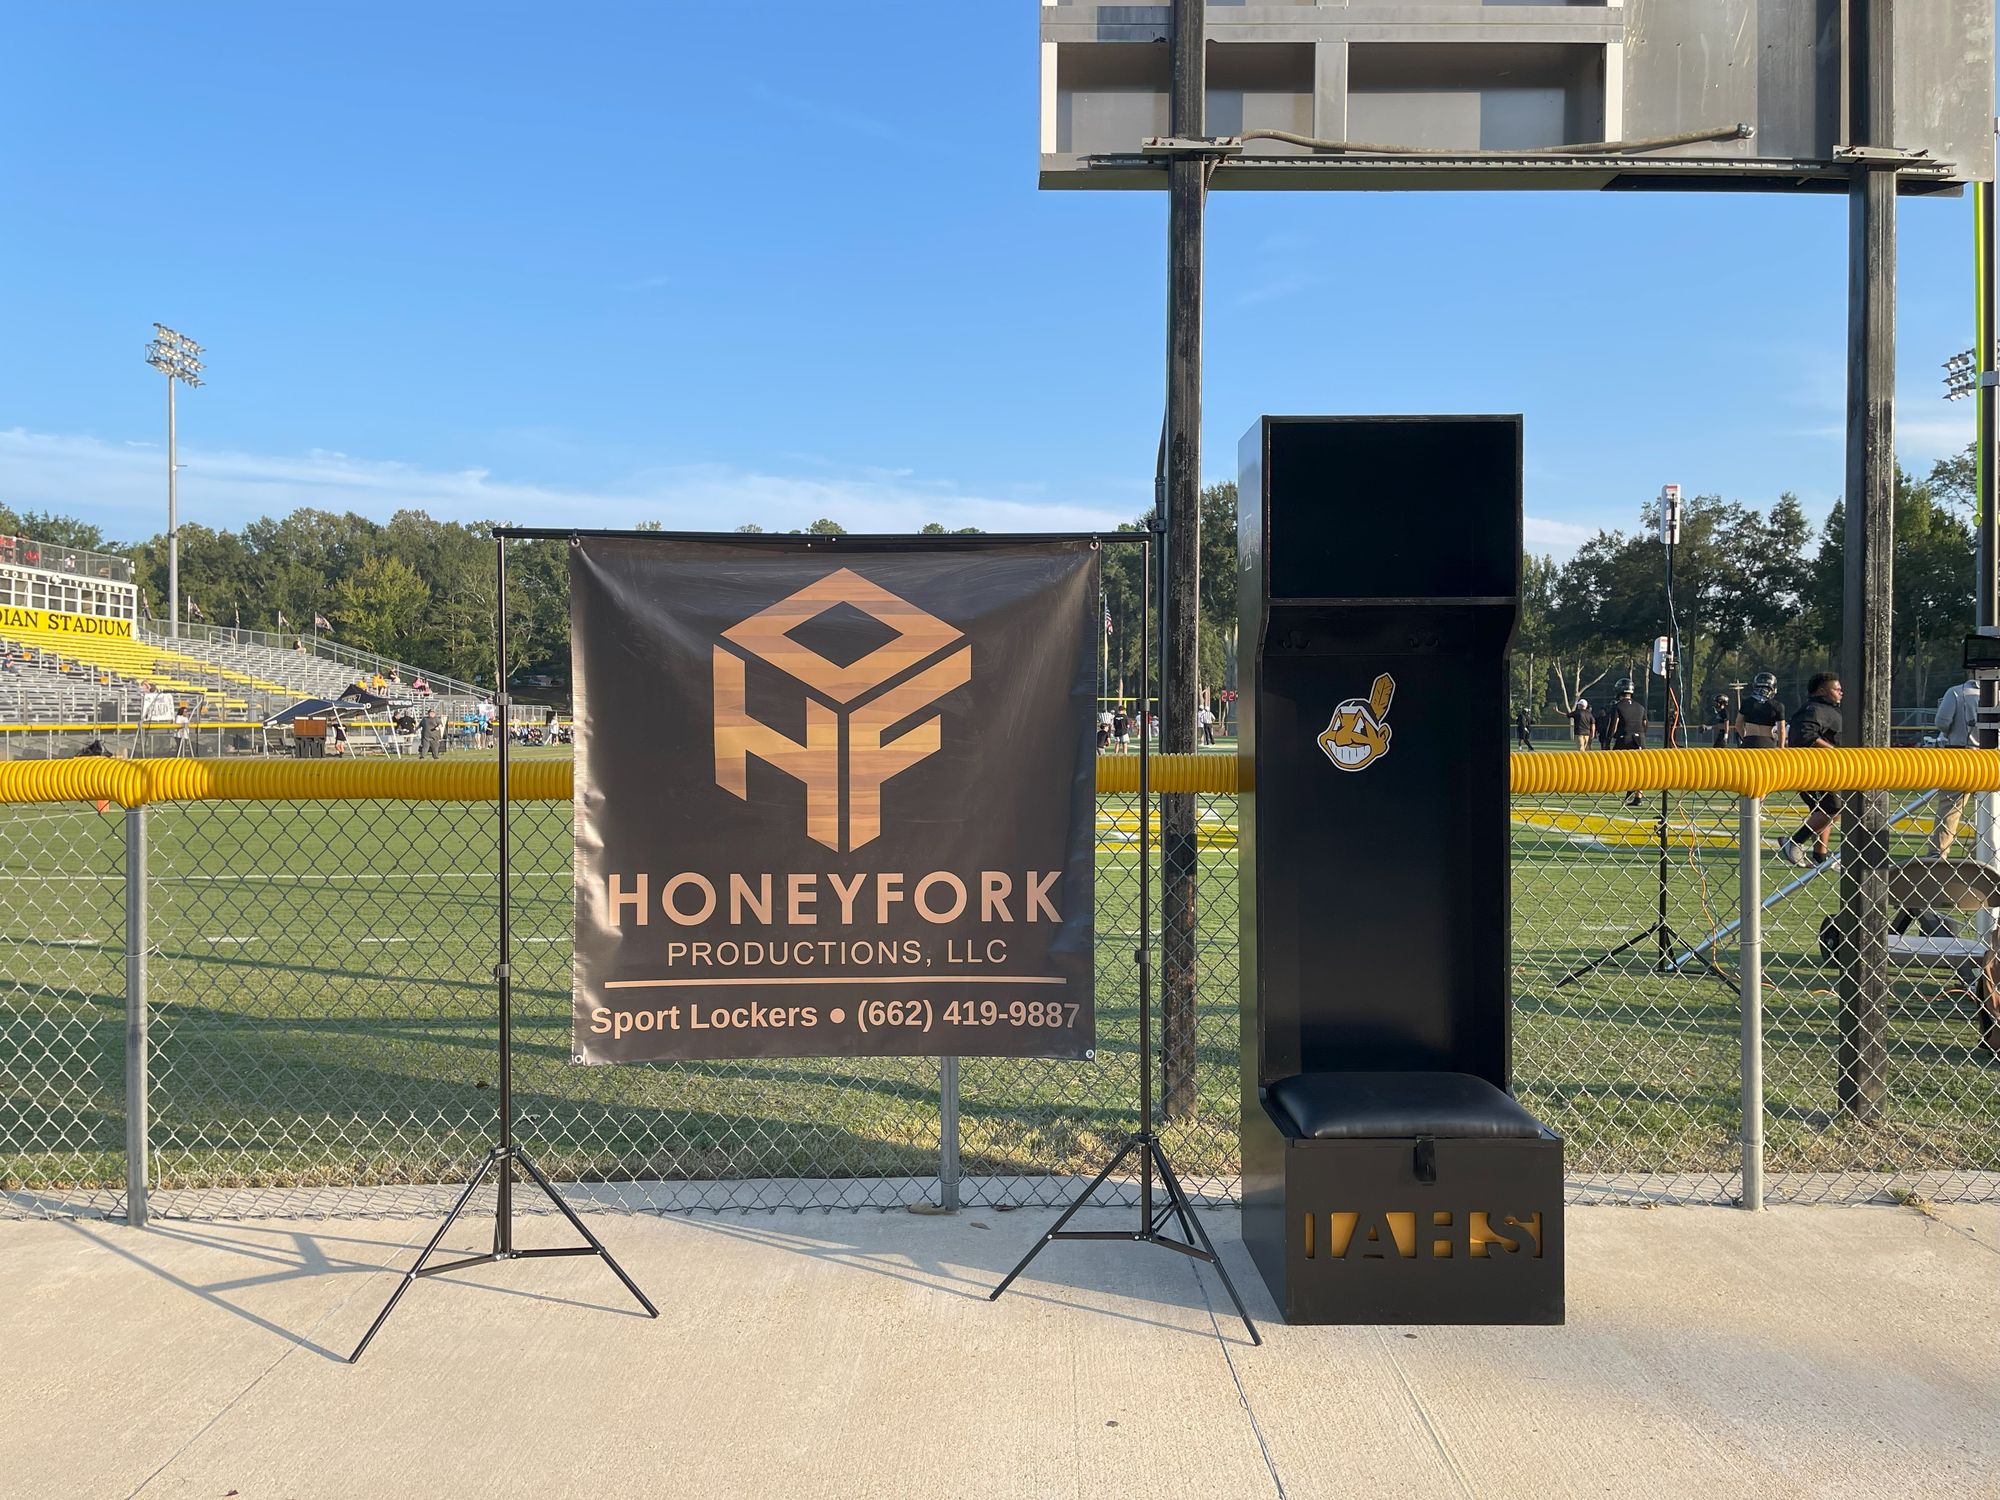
<box><xmin>1040</xmin><ymin>0</ymin><xmax>1994</xmax><ymax>194</ymax></box>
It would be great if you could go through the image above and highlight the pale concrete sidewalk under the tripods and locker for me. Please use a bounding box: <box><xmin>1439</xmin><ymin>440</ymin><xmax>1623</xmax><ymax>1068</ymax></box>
<box><xmin>0</xmin><ymin>1206</ymin><xmax>2000</xmax><ymax>1500</ymax></box>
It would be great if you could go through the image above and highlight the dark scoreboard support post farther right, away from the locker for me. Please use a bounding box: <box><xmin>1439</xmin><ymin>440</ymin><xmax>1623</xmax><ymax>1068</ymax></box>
<box><xmin>1836</xmin><ymin>0</ymin><xmax>1898</xmax><ymax>1122</ymax></box>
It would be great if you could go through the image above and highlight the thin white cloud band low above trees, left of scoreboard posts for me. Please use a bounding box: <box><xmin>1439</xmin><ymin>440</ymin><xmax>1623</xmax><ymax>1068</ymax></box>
<box><xmin>0</xmin><ymin>428</ymin><xmax>1130</xmax><ymax>540</ymax></box>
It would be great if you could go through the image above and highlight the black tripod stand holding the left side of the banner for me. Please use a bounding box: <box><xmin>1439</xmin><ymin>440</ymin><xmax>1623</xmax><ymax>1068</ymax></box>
<box><xmin>348</xmin><ymin>536</ymin><xmax>660</xmax><ymax>1364</ymax></box>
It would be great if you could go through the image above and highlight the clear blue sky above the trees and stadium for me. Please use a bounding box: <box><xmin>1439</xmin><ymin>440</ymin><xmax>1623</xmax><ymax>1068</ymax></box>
<box><xmin>0</xmin><ymin>0</ymin><xmax>1972</xmax><ymax>552</ymax></box>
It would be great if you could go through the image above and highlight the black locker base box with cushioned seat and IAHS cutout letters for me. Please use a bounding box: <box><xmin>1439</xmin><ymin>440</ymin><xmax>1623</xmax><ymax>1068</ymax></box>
<box><xmin>1242</xmin><ymin>1072</ymin><xmax>1564</xmax><ymax>1324</ymax></box>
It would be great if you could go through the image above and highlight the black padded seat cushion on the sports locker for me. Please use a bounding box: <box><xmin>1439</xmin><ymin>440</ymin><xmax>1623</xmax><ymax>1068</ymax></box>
<box><xmin>1268</xmin><ymin>1072</ymin><xmax>1542</xmax><ymax>1140</ymax></box>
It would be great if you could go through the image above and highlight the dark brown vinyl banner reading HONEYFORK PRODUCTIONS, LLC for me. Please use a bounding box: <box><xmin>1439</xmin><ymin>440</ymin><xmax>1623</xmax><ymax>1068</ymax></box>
<box><xmin>570</xmin><ymin>536</ymin><xmax>1100</xmax><ymax>1062</ymax></box>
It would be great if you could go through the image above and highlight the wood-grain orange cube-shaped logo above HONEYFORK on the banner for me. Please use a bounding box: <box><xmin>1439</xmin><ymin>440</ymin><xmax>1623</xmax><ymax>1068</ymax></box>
<box><xmin>714</xmin><ymin>568</ymin><xmax>972</xmax><ymax>852</ymax></box>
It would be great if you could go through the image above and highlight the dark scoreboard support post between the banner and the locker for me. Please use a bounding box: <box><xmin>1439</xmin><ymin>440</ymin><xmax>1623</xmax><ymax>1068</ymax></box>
<box><xmin>1140</xmin><ymin>0</ymin><xmax>1210</xmax><ymax>1120</ymax></box>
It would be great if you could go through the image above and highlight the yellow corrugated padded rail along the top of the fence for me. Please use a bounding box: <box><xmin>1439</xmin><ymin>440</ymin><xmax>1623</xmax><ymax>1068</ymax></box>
<box><xmin>0</xmin><ymin>750</ymin><xmax>2000</xmax><ymax>808</ymax></box>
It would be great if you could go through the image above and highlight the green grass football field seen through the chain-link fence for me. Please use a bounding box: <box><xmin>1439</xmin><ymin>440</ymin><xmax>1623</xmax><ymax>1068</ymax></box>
<box><xmin>0</xmin><ymin>764</ymin><xmax>2000</xmax><ymax>1224</ymax></box>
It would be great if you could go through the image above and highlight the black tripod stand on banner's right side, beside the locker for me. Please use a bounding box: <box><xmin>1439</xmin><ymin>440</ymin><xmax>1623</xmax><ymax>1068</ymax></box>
<box><xmin>986</xmin><ymin>542</ymin><xmax>1264</xmax><ymax>1344</ymax></box>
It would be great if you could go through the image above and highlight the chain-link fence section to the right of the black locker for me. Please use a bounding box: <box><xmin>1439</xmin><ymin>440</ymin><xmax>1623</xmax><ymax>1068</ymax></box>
<box><xmin>1512</xmin><ymin>790</ymin><xmax>2000</xmax><ymax>1202</ymax></box>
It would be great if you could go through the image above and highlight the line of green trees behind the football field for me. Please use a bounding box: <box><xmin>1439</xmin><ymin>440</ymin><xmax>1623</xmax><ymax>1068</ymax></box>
<box><xmin>0</xmin><ymin>446</ymin><xmax>1974</xmax><ymax>722</ymax></box>
